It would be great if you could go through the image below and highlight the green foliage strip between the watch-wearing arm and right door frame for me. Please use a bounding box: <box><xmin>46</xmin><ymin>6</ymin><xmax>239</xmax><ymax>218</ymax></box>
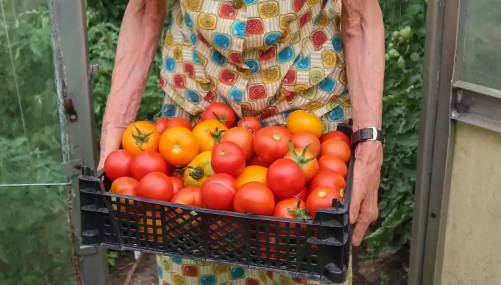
<box><xmin>366</xmin><ymin>0</ymin><xmax>426</xmax><ymax>254</ymax></box>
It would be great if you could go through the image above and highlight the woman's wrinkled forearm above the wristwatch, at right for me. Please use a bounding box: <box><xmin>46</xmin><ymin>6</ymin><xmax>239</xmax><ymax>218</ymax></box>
<box><xmin>341</xmin><ymin>0</ymin><xmax>385</xmax><ymax>130</ymax></box>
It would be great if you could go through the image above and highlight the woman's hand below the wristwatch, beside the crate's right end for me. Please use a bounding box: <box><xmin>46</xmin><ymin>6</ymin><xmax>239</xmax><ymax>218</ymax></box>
<box><xmin>350</xmin><ymin>141</ymin><xmax>383</xmax><ymax>246</ymax></box>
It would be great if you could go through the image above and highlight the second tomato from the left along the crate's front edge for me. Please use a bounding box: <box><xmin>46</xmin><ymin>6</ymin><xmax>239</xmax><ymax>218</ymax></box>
<box><xmin>137</xmin><ymin>172</ymin><xmax>174</xmax><ymax>201</ymax></box>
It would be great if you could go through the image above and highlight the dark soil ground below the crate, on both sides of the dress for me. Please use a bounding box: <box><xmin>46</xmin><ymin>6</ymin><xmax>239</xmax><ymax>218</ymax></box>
<box><xmin>110</xmin><ymin>248</ymin><xmax>408</xmax><ymax>285</ymax></box>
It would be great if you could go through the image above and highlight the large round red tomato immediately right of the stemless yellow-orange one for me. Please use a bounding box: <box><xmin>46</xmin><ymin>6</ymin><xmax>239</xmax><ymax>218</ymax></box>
<box><xmin>266</xmin><ymin>158</ymin><xmax>306</xmax><ymax>200</ymax></box>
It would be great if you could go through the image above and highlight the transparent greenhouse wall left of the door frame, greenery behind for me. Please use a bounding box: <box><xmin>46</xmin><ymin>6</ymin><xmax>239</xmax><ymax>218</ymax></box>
<box><xmin>0</xmin><ymin>0</ymin><xmax>75</xmax><ymax>285</ymax></box>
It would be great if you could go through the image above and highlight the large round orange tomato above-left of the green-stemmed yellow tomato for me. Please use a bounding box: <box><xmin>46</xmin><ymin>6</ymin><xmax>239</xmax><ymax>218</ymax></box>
<box><xmin>160</xmin><ymin>127</ymin><xmax>200</xmax><ymax>167</ymax></box>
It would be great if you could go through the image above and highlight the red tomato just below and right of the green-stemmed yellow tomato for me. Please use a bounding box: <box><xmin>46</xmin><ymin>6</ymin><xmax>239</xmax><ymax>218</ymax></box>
<box><xmin>202</xmin><ymin>173</ymin><xmax>237</xmax><ymax>211</ymax></box>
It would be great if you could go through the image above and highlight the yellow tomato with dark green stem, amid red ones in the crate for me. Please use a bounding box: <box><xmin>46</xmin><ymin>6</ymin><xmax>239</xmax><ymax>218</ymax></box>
<box><xmin>183</xmin><ymin>151</ymin><xmax>214</xmax><ymax>187</ymax></box>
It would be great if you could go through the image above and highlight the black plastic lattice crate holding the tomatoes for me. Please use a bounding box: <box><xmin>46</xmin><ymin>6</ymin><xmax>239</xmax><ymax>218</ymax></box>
<box><xmin>79</xmin><ymin>122</ymin><xmax>354</xmax><ymax>283</ymax></box>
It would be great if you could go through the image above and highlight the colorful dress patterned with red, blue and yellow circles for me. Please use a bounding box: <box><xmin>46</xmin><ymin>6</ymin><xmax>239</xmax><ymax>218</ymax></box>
<box><xmin>158</xmin><ymin>0</ymin><xmax>351</xmax><ymax>285</ymax></box>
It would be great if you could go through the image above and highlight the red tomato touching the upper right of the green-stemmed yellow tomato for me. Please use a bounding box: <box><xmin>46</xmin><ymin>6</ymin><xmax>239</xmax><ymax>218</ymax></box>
<box><xmin>211</xmin><ymin>141</ymin><xmax>245</xmax><ymax>177</ymax></box>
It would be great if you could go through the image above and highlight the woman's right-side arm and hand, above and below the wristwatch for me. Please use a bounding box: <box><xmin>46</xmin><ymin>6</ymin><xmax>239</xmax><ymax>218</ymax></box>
<box><xmin>341</xmin><ymin>0</ymin><xmax>385</xmax><ymax>246</ymax></box>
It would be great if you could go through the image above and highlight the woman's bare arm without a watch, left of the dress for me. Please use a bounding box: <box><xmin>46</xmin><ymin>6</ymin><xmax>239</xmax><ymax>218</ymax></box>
<box><xmin>98</xmin><ymin>0</ymin><xmax>167</xmax><ymax>169</ymax></box>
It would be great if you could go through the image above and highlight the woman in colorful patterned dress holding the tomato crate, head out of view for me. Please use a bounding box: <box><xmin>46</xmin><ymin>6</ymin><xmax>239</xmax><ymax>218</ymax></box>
<box><xmin>100</xmin><ymin>0</ymin><xmax>384</xmax><ymax>285</ymax></box>
